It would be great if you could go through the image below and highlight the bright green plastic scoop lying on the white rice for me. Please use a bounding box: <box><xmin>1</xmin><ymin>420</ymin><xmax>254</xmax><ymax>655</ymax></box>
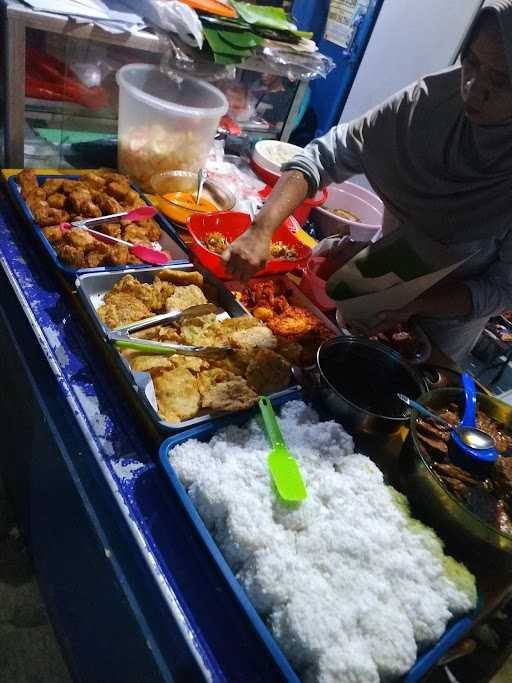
<box><xmin>258</xmin><ymin>396</ymin><xmax>308</xmax><ymax>503</ymax></box>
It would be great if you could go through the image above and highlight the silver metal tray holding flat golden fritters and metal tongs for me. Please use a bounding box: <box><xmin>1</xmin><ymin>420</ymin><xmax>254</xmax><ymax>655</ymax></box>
<box><xmin>76</xmin><ymin>263</ymin><xmax>296</xmax><ymax>433</ymax></box>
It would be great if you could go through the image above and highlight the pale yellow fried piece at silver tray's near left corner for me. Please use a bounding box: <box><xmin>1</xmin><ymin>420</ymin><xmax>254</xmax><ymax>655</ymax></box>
<box><xmin>151</xmin><ymin>368</ymin><xmax>201</xmax><ymax>422</ymax></box>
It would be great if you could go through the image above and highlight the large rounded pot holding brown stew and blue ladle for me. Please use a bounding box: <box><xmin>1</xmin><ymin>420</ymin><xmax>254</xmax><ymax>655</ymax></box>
<box><xmin>400</xmin><ymin>388</ymin><xmax>512</xmax><ymax>566</ymax></box>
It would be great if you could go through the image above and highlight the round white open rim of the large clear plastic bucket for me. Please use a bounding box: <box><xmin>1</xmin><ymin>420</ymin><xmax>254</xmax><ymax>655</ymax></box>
<box><xmin>116</xmin><ymin>64</ymin><xmax>229</xmax><ymax>118</ymax></box>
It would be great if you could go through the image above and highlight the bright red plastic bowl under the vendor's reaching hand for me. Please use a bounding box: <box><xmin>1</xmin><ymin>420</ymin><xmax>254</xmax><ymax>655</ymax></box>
<box><xmin>187</xmin><ymin>211</ymin><xmax>311</xmax><ymax>280</ymax></box>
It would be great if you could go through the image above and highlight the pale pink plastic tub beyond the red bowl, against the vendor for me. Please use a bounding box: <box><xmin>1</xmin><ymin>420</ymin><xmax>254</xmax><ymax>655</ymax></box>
<box><xmin>313</xmin><ymin>181</ymin><xmax>384</xmax><ymax>242</ymax></box>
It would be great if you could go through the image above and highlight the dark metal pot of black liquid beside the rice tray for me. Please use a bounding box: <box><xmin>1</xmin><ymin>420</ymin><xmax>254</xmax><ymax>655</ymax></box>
<box><xmin>317</xmin><ymin>336</ymin><xmax>427</xmax><ymax>434</ymax></box>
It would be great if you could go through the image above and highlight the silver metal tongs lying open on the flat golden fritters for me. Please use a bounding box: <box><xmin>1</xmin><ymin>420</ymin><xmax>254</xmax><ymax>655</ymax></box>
<box><xmin>108</xmin><ymin>304</ymin><xmax>233</xmax><ymax>360</ymax></box>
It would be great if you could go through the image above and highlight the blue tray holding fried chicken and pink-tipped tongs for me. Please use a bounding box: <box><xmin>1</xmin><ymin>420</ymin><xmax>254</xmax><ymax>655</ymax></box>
<box><xmin>7</xmin><ymin>175</ymin><xmax>190</xmax><ymax>278</ymax></box>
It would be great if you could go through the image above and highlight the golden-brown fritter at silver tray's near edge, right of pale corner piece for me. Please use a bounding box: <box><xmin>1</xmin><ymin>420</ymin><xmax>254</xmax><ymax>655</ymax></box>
<box><xmin>198</xmin><ymin>368</ymin><xmax>258</xmax><ymax>411</ymax></box>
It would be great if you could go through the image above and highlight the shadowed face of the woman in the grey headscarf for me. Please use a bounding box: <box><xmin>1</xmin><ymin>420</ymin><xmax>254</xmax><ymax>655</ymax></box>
<box><xmin>461</xmin><ymin>22</ymin><xmax>512</xmax><ymax>126</ymax></box>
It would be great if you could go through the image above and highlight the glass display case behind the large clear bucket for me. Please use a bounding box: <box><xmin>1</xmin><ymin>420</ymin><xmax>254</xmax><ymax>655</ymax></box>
<box><xmin>3</xmin><ymin>1</ymin><xmax>309</xmax><ymax>168</ymax></box>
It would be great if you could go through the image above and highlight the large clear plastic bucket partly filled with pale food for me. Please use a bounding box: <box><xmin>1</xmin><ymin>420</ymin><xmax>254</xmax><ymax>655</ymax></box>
<box><xmin>116</xmin><ymin>64</ymin><xmax>228</xmax><ymax>192</ymax></box>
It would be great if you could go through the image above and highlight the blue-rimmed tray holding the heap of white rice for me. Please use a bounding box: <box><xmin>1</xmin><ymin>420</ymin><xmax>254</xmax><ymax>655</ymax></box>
<box><xmin>159</xmin><ymin>390</ymin><xmax>476</xmax><ymax>683</ymax></box>
